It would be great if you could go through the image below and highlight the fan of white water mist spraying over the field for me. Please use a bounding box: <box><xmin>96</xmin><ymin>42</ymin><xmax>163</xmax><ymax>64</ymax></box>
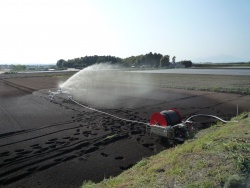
<box><xmin>61</xmin><ymin>63</ymin><xmax>152</xmax><ymax>108</ymax></box>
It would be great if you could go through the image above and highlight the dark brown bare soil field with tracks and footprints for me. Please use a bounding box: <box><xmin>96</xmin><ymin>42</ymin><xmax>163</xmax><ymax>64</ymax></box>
<box><xmin>0</xmin><ymin>73</ymin><xmax>250</xmax><ymax>187</ymax></box>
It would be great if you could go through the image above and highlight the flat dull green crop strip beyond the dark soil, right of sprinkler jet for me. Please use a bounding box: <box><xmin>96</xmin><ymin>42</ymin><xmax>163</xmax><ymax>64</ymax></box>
<box><xmin>91</xmin><ymin>71</ymin><xmax>250</xmax><ymax>95</ymax></box>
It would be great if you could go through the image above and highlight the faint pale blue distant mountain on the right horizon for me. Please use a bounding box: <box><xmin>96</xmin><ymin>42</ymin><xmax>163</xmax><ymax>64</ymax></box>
<box><xmin>193</xmin><ymin>55</ymin><xmax>250</xmax><ymax>63</ymax></box>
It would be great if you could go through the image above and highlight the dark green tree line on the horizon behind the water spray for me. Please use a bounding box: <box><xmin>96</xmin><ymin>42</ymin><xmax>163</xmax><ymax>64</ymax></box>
<box><xmin>56</xmin><ymin>52</ymin><xmax>192</xmax><ymax>69</ymax></box>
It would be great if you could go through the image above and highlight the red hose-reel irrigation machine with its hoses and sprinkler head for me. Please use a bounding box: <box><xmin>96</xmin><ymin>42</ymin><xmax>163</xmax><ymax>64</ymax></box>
<box><xmin>49</xmin><ymin>88</ymin><xmax>238</xmax><ymax>142</ymax></box>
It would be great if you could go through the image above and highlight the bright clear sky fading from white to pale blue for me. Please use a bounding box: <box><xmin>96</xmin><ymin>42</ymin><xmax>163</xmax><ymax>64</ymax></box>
<box><xmin>0</xmin><ymin>0</ymin><xmax>250</xmax><ymax>64</ymax></box>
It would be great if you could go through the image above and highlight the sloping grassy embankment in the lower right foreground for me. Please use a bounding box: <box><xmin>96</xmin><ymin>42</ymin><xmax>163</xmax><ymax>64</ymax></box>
<box><xmin>82</xmin><ymin>113</ymin><xmax>250</xmax><ymax>188</ymax></box>
